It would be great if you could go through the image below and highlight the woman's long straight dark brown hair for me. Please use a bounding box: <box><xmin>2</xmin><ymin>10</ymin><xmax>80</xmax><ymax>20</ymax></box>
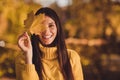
<box><xmin>31</xmin><ymin>7</ymin><xmax>74</xmax><ymax>80</ymax></box>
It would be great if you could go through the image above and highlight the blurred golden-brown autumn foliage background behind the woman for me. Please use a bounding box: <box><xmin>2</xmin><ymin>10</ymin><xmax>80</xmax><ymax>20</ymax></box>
<box><xmin>0</xmin><ymin>0</ymin><xmax>120</xmax><ymax>80</ymax></box>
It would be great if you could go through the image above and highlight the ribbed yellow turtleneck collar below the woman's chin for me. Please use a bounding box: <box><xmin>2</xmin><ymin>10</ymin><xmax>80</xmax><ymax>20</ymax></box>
<box><xmin>39</xmin><ymin>44</ymin><xmax>57</xmax><ymax>59</ymax></box>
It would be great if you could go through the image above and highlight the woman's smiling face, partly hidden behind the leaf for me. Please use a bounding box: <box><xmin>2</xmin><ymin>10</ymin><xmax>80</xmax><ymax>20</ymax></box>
<box><xmin>39</xmin><ymin>16</ymin><xmax>57</xmax><ymax>45</ymax></box>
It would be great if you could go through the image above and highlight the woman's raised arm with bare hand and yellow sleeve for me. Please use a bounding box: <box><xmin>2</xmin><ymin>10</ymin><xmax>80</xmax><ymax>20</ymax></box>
<box><xmin>15</xmin><ymin>32</ymin><xmax>39</xmax><ymax>80</ymax></box>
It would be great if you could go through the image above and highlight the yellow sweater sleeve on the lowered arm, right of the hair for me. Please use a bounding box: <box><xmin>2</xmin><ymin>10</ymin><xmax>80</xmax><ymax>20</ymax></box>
<box><xmin>68</xmin><ymin>50</ymin><xmax>83</xmax><ymax>80</ymax></box>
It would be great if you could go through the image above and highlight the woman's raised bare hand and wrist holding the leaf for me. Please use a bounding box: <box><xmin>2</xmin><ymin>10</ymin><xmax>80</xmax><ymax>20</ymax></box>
<box><xmin>18</xmin><ymin>32</ymin><xmax>33</xmax><ymax>64</ymax></box>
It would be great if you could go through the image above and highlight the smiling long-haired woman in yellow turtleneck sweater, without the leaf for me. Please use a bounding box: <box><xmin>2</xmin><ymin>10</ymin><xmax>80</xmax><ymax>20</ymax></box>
<box><xmin>16</xmin><ymin>7</ymin><xmax>83</xmax><ymax>80</ymax></box>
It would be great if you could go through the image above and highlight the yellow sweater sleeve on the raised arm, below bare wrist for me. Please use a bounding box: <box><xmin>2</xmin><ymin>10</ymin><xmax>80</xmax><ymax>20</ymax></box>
<box><xmin>15</xmin><ymin>54</ymin><xmax>39</xmax><ymax>80</ymax></box>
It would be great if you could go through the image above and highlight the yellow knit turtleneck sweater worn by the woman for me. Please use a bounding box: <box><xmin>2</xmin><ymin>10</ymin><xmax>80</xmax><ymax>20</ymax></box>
<box><xmin>15</xmin><ymin>46</ymin><xmax>83</xmax><ymax>80</ymax></box>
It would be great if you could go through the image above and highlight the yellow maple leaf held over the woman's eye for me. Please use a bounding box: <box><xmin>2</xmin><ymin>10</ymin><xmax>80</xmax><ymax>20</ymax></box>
<box><xmin>25</xmin><ymin>12</ymin><xmax>45</xmax><ymax>35</ymax></box>
